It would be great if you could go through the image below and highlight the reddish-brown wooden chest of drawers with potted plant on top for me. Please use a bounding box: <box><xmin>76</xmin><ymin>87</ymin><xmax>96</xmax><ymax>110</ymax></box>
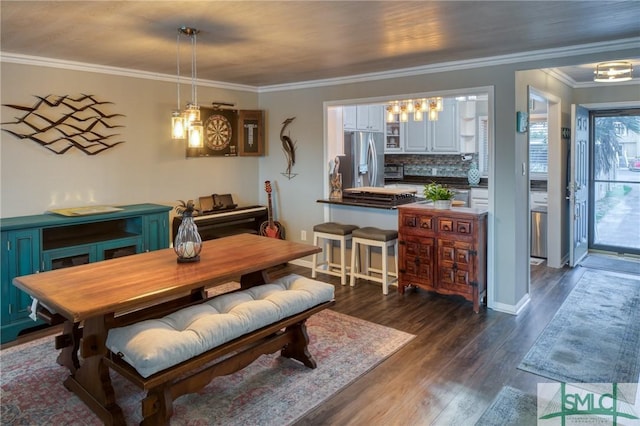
<box><xmin>398</xmin><ymin>203</ymin><xmax>487</xmax><ymax>312</ymax></box>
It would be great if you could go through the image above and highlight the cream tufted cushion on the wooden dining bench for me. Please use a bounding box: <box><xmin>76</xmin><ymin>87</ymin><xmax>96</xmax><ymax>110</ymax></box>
<box><xmin>106</xmin><ymin>274</ymin><xmax>334</xmax><ymax>377</ymax></box>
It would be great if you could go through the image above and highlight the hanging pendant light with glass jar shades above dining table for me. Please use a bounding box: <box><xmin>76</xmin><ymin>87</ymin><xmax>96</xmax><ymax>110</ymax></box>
<box><xmin>171</xmin><ymin>27</ymin><xmax>204</xmax><ymax>148</ymax></box>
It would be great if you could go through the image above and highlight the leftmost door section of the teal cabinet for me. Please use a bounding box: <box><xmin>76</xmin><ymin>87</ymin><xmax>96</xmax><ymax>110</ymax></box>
<box><xmin>0</xmin><ymin>229</ymin><xmax>43</xmax><ymax>343</ymax></box>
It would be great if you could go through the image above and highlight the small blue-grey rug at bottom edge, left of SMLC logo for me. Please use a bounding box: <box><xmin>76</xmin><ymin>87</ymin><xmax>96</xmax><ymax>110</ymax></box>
<box><xmin>476</xmin><ymin>386</ymin><xmax>538</xmax><ymax>426</ymax></box>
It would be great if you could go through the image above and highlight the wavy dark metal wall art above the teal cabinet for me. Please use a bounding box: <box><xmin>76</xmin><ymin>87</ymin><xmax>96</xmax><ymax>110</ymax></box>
<box><xmin>1</xmin><ymin>94</ymin><xmax>125</xmax><ymax>155</ymax></box>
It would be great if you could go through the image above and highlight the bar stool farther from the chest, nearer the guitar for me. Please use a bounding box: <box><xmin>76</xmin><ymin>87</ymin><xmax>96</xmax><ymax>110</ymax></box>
<box><xmin>311</xmin><ymin>222</ymin><xmax>358</xmax><ymax>285</ymax></box>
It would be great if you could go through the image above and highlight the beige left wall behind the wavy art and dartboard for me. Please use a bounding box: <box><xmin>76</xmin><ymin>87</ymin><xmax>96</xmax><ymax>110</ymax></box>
<box><xmin>0</xmin><ymin>62</ymin><xmax>261</xmax><ymax>217</ymax></box>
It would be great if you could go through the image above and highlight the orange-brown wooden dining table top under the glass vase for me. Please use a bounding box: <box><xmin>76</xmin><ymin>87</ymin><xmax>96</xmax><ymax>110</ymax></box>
<box><xmin>13</xmin><ymin>234</ymin><xmax>321</xmax><ymax>322</ymax></box>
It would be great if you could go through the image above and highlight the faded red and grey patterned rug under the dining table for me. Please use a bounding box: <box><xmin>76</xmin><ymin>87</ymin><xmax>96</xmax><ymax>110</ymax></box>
<box><xmin>0</xmin><ymin>310</ymin><xmax>415</xmax><ymax>426</ymax></box>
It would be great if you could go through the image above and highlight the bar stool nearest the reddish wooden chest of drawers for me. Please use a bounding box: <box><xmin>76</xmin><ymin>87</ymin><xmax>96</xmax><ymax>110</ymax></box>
<box><xmin>350</xmin><ymin>227</ymin><xmax>398</xmax><ymax>294</ymax></box>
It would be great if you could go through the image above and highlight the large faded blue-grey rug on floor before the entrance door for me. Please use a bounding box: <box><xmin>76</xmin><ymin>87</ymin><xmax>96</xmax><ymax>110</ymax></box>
<box><xmin>518</xmin><ymin>271</ymin><xmax>640</xmax><ymax>383</ymax></box>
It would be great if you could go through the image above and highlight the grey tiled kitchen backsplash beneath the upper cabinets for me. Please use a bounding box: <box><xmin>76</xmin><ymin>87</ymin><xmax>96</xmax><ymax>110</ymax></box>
<box><xmin>384</xmin><ymin>154</ymin><xmax>477</xmax><ymax>178</ymax></box>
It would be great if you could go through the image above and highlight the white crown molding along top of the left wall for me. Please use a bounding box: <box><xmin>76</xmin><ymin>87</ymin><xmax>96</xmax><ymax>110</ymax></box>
<box><xmin>0</xmin><ymin>52</ymin><xmax>258</xmax><ymax>93</ymax></box>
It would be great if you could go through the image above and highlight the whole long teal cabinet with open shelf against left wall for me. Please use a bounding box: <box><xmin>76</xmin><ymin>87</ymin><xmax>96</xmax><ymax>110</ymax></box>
<box><xmin>0</xmin><ymin>204</ymin><xmax>171</xmax><ymax>343</ymax></box>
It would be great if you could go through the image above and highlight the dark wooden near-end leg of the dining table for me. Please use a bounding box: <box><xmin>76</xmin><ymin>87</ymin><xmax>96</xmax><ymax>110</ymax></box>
<box><xmin>64</xmin><ymin>317</ymin><xmax>126</xmax><ymax>425</ymax></box>
